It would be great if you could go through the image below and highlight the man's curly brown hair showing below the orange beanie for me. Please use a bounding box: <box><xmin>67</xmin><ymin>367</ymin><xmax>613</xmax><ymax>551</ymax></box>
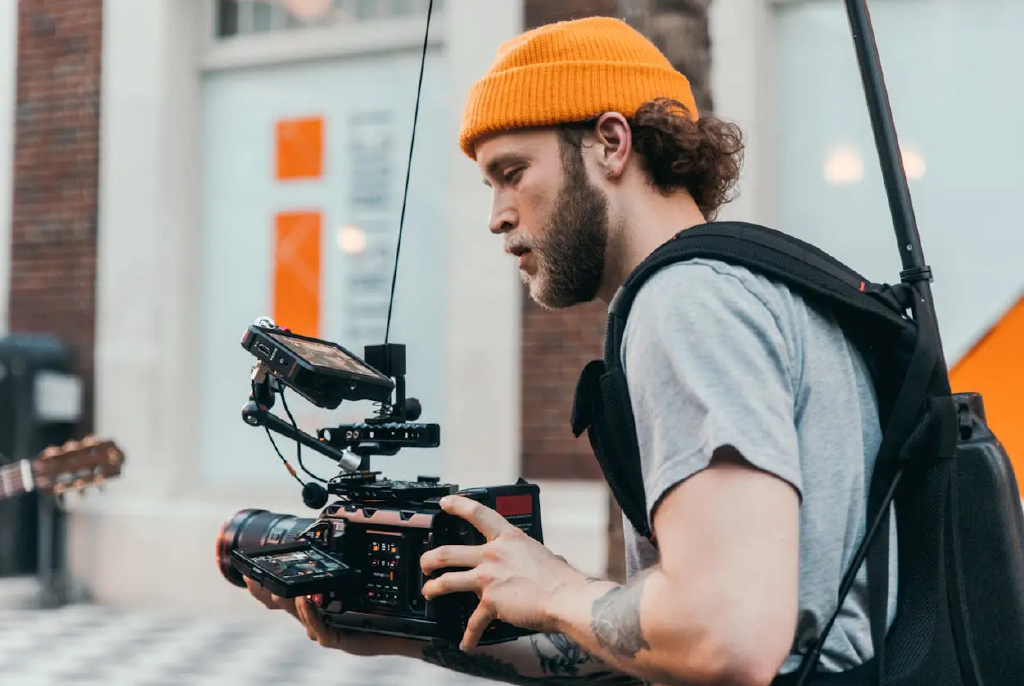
<box><xmin>559</xmin><ymin>98</ymin><xmax>743</xmax><ymax>220</ymax></box>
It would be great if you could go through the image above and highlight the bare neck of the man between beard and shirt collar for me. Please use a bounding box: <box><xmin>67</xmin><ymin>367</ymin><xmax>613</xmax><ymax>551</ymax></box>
<box><xmin>598</xmin><ymin>190</ymin><xmax>707</xmax><ymax>304</ymax></box>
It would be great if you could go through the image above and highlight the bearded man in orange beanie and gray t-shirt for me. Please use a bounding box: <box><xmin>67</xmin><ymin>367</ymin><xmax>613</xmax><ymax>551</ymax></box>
<box><xmin>250</xmin><ymin>17</ymin><xmax>895</xmax><ymax>686</ymax></box>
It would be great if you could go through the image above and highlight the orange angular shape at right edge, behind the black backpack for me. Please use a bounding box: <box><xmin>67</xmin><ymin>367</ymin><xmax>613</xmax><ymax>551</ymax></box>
<box><xmin>949</xmin><ymin>297</ymin><xmax>1024</xmax><ymax>487</ymax></box>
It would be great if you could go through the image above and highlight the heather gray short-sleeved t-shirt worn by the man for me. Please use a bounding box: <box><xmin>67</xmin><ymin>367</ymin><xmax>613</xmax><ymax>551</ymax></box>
<box><xmin>622</xmin><ymin>259</ymin><xmax>896</xmax><ymax>673</ymax></box>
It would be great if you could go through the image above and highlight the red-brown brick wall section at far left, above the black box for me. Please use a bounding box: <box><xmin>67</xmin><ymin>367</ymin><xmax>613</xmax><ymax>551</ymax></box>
<box><xmin>10</xmin><ymin>0</ymin><xmax>103</xmax><ymax>438</ymax></box>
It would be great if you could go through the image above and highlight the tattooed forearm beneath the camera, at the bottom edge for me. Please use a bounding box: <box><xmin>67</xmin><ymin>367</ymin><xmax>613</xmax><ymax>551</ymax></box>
<box><xmin>413</xmin><ymin>634</ymin><xmax>644</xmax><ymax>686</ymax></box>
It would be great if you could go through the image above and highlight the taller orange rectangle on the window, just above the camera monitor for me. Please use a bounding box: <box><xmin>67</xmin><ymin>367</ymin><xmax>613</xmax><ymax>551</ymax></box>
<box><xmin>272</xmin><ymin>212</ymin><xmax>323</xmax><ymax>338</ymax></box>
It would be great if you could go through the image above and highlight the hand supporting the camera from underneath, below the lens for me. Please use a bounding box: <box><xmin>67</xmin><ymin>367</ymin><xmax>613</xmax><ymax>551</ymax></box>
<box><xmin>245</xmin><ymin>576</ymin><xmax>422</xmax><ymax>657</ymax></box>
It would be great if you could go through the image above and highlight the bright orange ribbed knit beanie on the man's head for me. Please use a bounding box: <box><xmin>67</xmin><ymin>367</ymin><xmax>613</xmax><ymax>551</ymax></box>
<box><xmin>459</xmin><ymin>16</ymin><xmax>697</xmax><ymax>160</ymax></box>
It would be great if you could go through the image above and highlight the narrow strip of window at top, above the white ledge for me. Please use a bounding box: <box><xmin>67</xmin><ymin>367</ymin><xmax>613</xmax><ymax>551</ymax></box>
<box><xmin>216</xmin><ymin>0</ymin><xmax>443</xmax><ymax>39</ymax></box>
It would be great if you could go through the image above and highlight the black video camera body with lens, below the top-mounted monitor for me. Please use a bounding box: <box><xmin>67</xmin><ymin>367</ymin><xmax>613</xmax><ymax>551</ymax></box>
<box><xmin>221</xmin><ymin>479</ymin><xmax>543</xmax><ymax>645</ymax></box>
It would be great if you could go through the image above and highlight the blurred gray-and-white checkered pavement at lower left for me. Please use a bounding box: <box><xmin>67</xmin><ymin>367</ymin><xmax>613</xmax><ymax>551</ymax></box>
<box><xmin>0</xmin><ymin>605</ymin><xmax>494</xmax><ymax>686</ymax></box>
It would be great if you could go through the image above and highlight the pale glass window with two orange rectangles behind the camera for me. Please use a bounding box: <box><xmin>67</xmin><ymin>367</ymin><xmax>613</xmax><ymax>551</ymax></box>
<box><xmin>198</xmin><ymin>51</ymin><xmax>453</xmax><ymax>483</ymax></box>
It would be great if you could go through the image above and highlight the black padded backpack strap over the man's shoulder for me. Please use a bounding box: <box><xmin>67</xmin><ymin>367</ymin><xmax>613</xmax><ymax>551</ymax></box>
<box><xmin>572</xmin><ymin>222</ymin><xmax>956</xmax><ymax>684</ymax></box>
